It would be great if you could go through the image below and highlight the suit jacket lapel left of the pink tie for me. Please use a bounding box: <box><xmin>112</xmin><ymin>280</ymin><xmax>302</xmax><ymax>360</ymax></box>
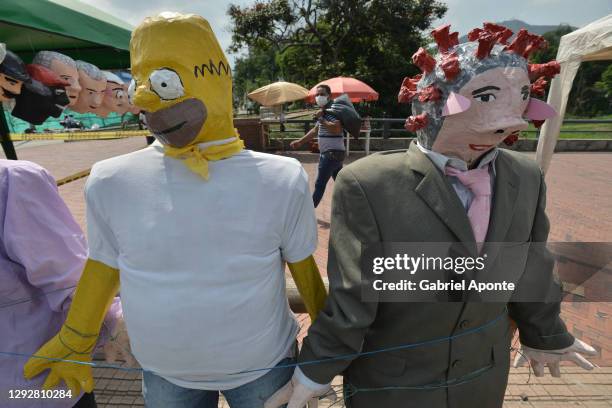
<box><xmin>408</xmin><ymin>142</ymin><xmax>476</xmax><ymax>254</ymax></box>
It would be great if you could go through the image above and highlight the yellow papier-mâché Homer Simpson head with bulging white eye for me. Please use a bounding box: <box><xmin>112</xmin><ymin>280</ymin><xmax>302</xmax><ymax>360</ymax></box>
<box><xmin>128</xmin><ymin>12</ymin><xmax>237</xmax><ymax>148</ymax></box>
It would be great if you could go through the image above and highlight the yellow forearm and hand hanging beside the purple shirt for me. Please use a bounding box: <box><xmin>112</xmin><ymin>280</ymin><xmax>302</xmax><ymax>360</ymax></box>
<box><xmin>23</xmin><ymin>259</ymin><xmax>119</xmax><ymax>395</ymax></box>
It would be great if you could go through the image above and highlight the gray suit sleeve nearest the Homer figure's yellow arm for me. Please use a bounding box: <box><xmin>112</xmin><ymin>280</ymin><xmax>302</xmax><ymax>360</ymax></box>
<box><xmin>298</xmin><ymin>168</ymin><xmax>380</xmax><ymax>384</ymax></box>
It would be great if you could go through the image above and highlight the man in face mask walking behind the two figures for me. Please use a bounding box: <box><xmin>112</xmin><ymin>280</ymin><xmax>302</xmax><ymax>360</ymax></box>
<box><xmin>291</xmin><ymin>84</ymin><xmax>346</xmax><ymax>208</ymax></box>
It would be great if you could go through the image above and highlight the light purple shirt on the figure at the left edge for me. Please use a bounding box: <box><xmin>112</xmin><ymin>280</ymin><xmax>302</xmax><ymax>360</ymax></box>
<box><xmin>0</xmin><ymin>160</ymin><xmax>121</xmax><ymax>408</ymax></box>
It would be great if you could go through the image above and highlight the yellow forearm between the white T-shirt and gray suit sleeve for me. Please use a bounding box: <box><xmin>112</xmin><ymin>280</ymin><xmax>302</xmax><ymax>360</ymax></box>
<box><xmin>289</xmin><ymin>255</ymin><xmax>327</xmax><ymax>322</ymax></box>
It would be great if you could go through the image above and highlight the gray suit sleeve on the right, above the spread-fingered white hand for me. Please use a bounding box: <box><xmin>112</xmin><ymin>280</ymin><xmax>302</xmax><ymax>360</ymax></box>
<box><xmin>508</xmin><ymin>173</ymin><xmax>574</xmax><ymax>350</ymax></box>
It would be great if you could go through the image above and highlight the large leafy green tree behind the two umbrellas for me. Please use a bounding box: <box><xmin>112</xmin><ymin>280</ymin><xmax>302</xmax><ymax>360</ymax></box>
<box><xmin>228</xmin><ymin>0</ymin><xmax>446</xmax><ymax>116</ymax></box>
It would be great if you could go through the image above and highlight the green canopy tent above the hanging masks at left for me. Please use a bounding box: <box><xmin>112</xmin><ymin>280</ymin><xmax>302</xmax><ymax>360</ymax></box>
<box><xmin>0</xmin><ymin>0</ymin><xmax>132</xmax><ymax>159</ymax></box>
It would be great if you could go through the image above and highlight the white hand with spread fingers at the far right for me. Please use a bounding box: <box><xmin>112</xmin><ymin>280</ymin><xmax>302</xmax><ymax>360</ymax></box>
<box><xmin>514</xmin><ymin>339</ymin><xmax>597</xmax><ymax>377</ymax></box>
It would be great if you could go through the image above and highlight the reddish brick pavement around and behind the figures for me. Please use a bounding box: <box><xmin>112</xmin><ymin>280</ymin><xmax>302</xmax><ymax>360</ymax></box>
<box><xmin>5</xmin><ymin>138</ymin><xmax>612</xmax><ymax>408</ymax></box>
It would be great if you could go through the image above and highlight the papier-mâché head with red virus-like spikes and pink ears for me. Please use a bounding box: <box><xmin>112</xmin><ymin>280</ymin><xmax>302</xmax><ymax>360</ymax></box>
<box><xmin>398</xmin><ymin>23</ymin><xmax>558</xmax><ymax>163</ymax></box>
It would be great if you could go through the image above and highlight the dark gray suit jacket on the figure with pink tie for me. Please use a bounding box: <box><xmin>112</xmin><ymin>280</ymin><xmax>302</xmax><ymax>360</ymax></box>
<box><xmin>299</xmin><ymin>143</ymin><xmax>573</xmax><ymax>408</ymax></box>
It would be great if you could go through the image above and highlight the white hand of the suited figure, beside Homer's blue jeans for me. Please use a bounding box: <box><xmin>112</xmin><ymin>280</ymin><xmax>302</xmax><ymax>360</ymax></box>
<box><xmin>264</xmin><ymin>367</ymin><xmax>338</xmax><ymax>408</ymax></box>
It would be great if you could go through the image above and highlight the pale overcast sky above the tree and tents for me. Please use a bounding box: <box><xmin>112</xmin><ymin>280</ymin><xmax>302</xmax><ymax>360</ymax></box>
<box><xmin>81</xmin><ymin>0</ymin><xmax>612</xmax><ymax>65</ymax></box>
